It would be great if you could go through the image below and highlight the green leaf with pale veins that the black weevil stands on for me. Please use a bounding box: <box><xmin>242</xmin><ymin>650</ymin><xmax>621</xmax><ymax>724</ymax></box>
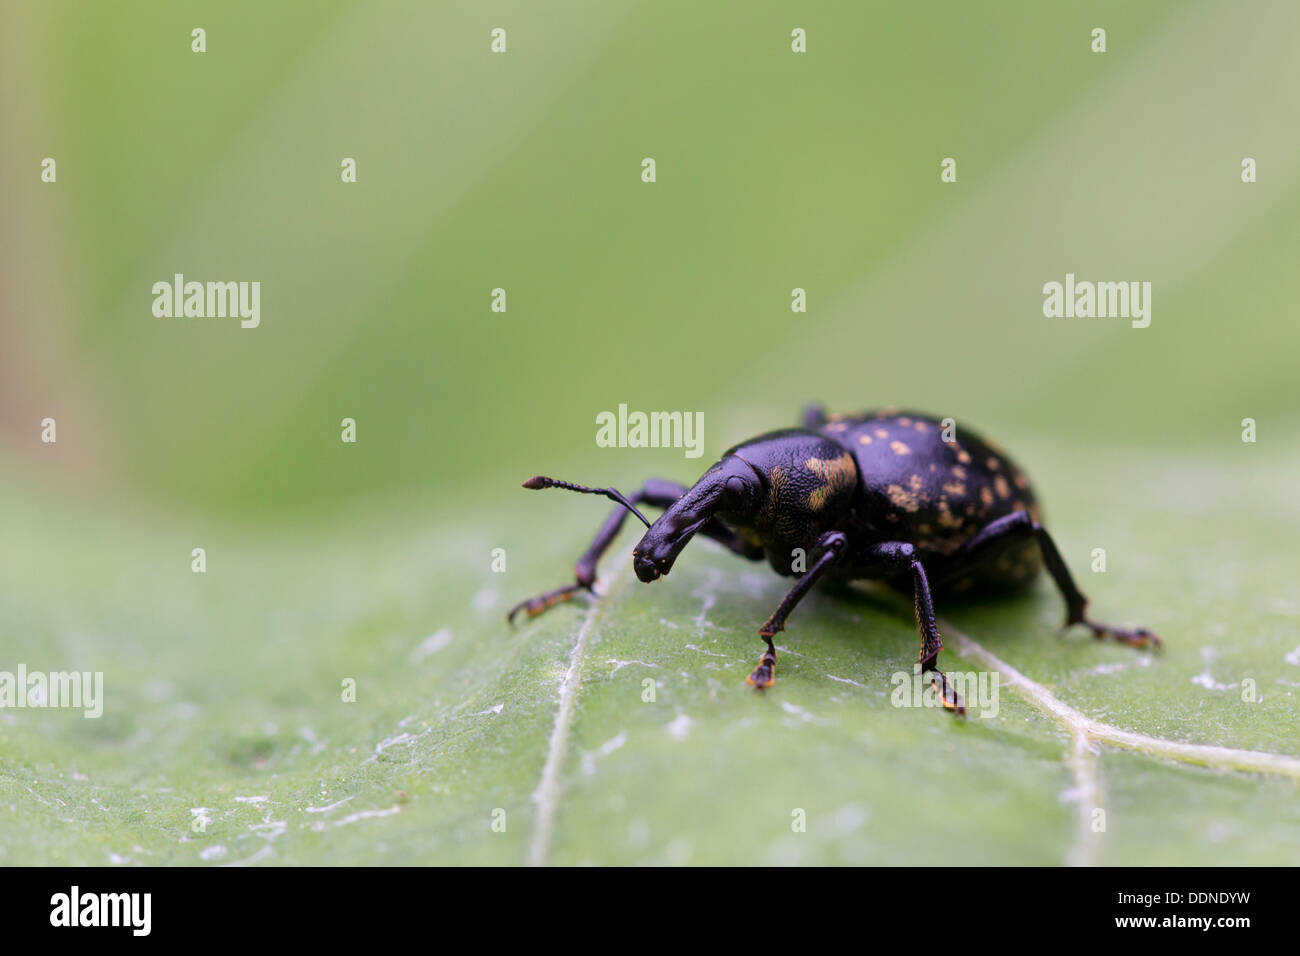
<box><xmin>0</xmin><ymin>436</ymin><xmax>1300</xmax><ymax>865</ymax></box>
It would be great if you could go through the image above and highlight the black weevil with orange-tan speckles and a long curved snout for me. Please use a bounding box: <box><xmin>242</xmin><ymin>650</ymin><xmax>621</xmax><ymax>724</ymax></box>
<box><xmin>507</xmin><ymin>405</ymin><xmax>1160</xmax><ymax>714</ymax></box>
